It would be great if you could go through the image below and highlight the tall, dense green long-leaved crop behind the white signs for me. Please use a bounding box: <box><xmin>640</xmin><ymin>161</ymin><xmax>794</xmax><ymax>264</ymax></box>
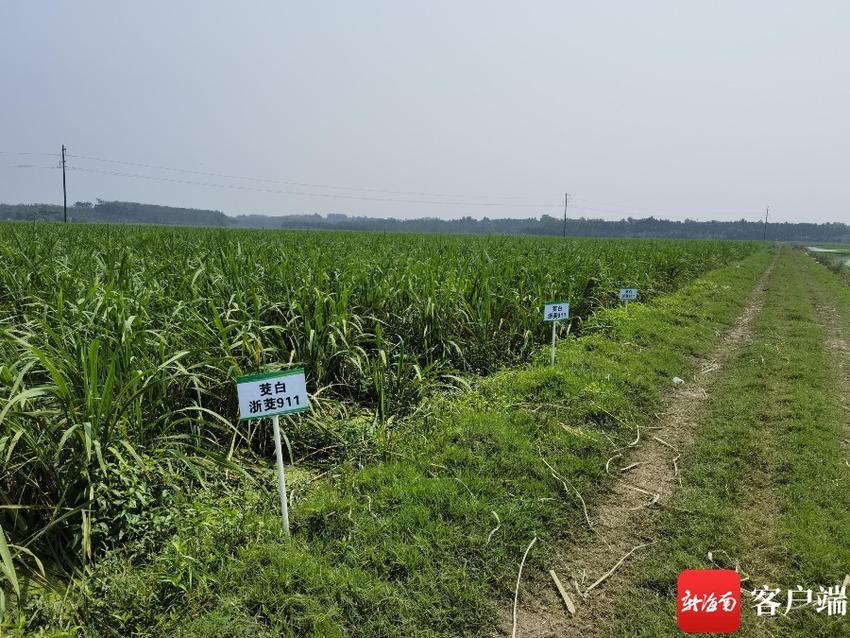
<box><xmin>0</xmin><ymin>225</ymin><xmax>753</xmax><ymax>568</ymax></box>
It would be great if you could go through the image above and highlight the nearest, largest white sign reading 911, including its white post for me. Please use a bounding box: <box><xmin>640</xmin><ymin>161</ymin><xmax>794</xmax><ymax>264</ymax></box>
<box><xmin>236</xmin><ymin>368</ymin><xmax>310</xmax><ymax>535</ymax></box>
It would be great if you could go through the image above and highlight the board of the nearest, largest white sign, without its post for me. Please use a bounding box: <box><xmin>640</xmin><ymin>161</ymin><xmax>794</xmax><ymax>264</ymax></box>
<box><xmin>236</xmin><ymin>368</ymin><xmax>310</xmax><ymax>421</ymax></box>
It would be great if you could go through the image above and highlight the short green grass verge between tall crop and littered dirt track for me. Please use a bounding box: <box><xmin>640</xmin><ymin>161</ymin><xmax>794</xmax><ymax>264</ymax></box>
<box><xmin>41</xmin><ymin>252</ymin><xmax>771</xmax><ymax>637</ymax></box>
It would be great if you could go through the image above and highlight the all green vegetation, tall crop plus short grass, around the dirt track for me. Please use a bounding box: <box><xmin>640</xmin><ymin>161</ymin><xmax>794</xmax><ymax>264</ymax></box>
<box><xmin>0</xmin><ymin>224</ymin><xmax>850</xmax><ymax>637</ymax></box>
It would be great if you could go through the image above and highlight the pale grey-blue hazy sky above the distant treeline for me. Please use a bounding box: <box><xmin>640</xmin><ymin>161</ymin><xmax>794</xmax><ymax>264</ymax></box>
<box><xmin>0</xmin><ymin>0</ymin><xmax>850</xmax><ymax>221</ymax></box>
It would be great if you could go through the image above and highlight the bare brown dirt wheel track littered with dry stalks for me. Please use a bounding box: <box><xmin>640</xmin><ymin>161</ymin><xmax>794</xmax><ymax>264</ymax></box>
<box><xmin>502</xmin><ymin>252</ymin><xmax>776</xmax><ymax>638</ymax></box>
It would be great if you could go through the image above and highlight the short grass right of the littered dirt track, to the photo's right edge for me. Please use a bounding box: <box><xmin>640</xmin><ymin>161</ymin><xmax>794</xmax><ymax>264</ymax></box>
<box><xmin>610</xmin><ymin>249</ymin><xmax>850</xmax><ymax>636</ymax></box>
